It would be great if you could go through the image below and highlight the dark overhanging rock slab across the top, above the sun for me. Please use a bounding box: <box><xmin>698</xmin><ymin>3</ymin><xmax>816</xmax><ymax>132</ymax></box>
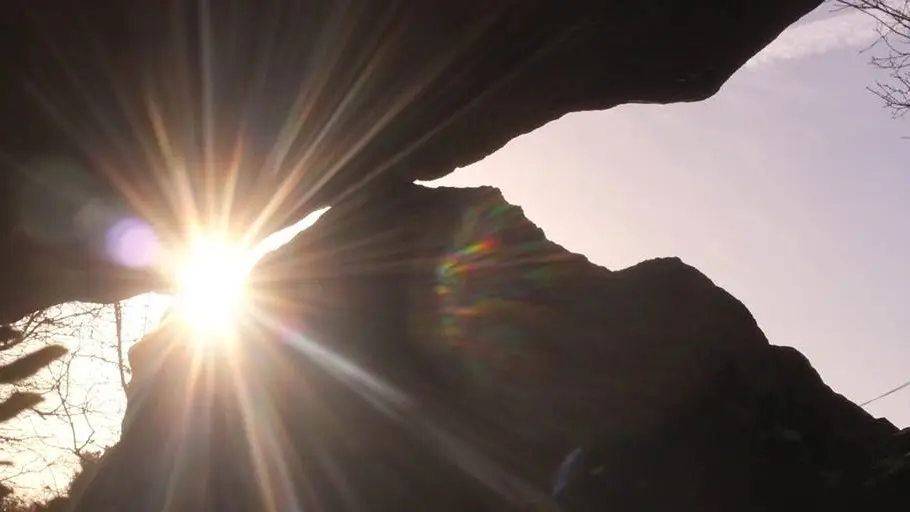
<box><xmin>0</xmin><ymin>0</ymin><xmax>821</xmax><ymax>322</ymax></box>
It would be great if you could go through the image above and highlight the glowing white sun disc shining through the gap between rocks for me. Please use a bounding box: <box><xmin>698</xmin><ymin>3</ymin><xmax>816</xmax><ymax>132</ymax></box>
<box><xmin>174</xmin><ymin>238</ymin><xmax>252</xmax><ymax>339</ymax></box>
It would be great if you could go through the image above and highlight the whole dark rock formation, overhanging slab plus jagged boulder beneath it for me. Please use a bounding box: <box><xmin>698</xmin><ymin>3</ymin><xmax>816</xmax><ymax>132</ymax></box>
<box><xmin>0</xmin><ymin>0</ymin><xmax>908</xmax><ymax>512</ymax></box>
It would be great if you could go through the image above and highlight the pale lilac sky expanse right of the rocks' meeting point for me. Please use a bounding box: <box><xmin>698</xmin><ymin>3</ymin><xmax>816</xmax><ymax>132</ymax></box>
<box><xmin>440</xmin><ymin>8</ymin><xmax>910</xmax><ymax>426</ymax></box>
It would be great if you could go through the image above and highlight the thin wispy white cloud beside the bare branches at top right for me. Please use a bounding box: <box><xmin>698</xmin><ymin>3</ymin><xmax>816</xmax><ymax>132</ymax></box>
<box><xmin>746</xmin><ymin>11</ymin><xmax>878</xmax><ymax>67</ymax></box>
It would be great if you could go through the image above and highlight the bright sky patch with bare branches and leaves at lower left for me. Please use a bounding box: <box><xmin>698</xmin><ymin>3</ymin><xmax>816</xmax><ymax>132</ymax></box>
<box><xmin>0</xmin><ymin>299</ymin><xmax>157</xmax><ymax>512</ymax></box>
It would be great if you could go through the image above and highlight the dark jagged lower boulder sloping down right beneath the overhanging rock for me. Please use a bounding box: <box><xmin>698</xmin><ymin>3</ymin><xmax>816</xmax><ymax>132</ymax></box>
<box><xmin>77</xmin><ymin>185</ymin><xmax>910</xmax><ymax>512</ymax></box>
